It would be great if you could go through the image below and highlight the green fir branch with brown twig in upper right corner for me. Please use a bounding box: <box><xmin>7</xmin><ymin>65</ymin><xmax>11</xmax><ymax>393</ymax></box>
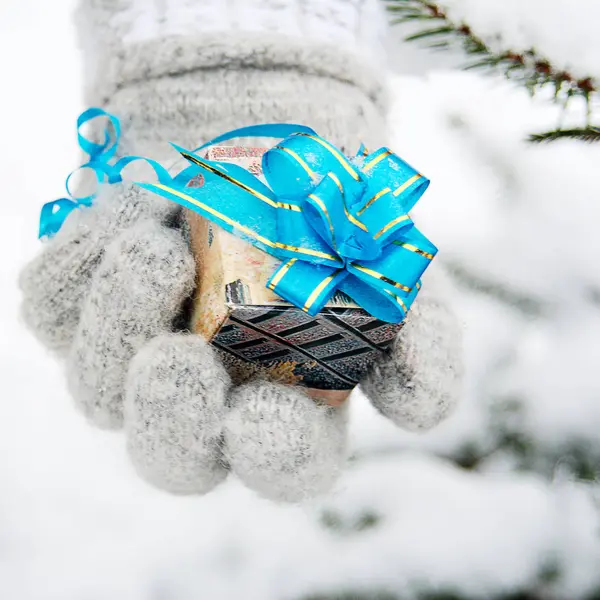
<box><xmin>384</xmin><ymin>0</ymin><xmax>600</xmax><ymax>142</ymax></box>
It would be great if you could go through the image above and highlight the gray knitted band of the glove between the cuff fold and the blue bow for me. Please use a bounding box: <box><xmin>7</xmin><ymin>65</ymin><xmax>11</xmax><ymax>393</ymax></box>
<box><xmin>104</xmin><ymin>63</ymin><xmax>386</xmax><ymax>159</ymax></box>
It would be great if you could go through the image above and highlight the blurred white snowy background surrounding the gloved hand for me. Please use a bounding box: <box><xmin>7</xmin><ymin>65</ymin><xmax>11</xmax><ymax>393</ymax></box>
<box><xmin>0</xmin><ymin>0</ymin><xmax>600</xmax><ymax>600</ymax></box>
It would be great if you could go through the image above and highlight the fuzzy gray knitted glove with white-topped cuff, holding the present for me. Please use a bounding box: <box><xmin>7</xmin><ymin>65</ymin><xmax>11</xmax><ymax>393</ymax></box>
<box><xmin>20</xmin><ymin>0</ymin><xmax>460</xmax><ymax>501</ymax></box>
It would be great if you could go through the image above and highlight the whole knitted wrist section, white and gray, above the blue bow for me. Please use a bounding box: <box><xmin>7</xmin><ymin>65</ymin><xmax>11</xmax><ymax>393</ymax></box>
<box><xmin>77</xmin><ymin>0</ymin><xmax>386</xmax><ymax>161</ymax></box>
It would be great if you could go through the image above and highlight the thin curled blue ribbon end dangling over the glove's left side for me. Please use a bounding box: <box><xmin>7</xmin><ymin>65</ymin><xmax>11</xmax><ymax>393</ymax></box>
<box><xmin>38</xmin><ymin>108</ymin><xmax>171</xmax><ymax>238</ymax></box>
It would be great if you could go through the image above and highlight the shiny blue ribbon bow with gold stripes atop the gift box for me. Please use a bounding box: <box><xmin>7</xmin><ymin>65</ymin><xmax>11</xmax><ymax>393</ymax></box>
<box><xmin>139</xmin><ymin>124</ymin><xmax>437</xmax><ymax>323</ymax></box>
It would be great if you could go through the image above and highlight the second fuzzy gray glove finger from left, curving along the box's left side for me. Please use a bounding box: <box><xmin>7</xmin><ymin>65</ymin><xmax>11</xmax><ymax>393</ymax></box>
<box><xmin>67</xmin><ymin>221</ymin><xmax>195</xmax><ymax>429</ymax></box>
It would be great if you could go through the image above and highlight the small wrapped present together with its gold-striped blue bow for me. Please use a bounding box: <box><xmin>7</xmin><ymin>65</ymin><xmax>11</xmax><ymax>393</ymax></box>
<box><xmin>141</xmin><ymin>125</ymin><xmax>437</xmax><ymax>404</ymax></box>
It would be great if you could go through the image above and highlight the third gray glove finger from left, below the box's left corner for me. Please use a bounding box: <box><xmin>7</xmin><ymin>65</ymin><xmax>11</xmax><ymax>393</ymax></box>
<box><xmin>125</xmin><ymin>334</ymin><xmax>230</xmax><ymax>494</ymax></box>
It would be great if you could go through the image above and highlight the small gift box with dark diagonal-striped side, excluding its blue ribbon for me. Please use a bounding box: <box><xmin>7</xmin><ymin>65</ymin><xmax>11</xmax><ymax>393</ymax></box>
<box><xmin>186</xmin><ymin>146</ymin><xmax>402</xmax><ymax>405</ymax></box>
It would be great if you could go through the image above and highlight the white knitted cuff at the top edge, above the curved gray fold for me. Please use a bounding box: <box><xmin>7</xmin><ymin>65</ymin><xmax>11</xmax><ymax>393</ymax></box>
<box><xmin>77</xmin><ymin>0</ymin><xmax>385</xmax><ymax>104</ymax></box>
